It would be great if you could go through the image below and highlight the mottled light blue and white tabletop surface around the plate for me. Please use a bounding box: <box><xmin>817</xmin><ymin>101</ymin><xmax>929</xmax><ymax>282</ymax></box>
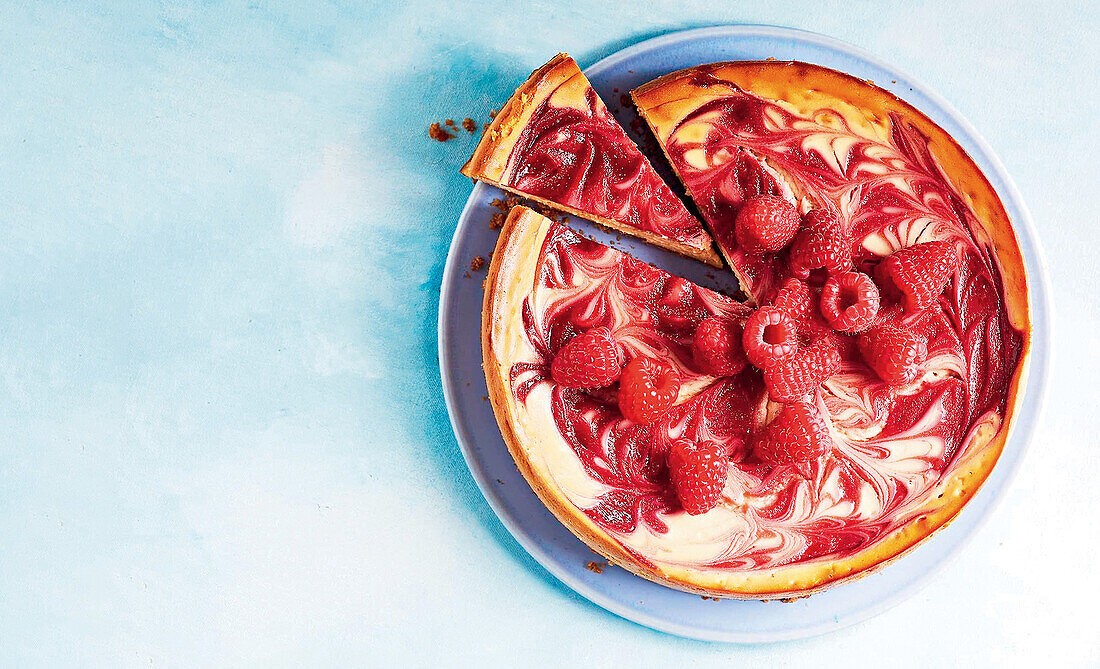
<box><xmin>0</xmin><ymin>0</ymin><xmax>1100</xmax><ymax>667</ymax></box>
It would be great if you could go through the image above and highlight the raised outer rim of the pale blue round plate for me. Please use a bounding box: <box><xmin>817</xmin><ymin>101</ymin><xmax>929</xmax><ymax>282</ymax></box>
<box><xmin>437</xmin><ymin>24</ymin><xmax>1053</xmax><ymax>644</ymax></box>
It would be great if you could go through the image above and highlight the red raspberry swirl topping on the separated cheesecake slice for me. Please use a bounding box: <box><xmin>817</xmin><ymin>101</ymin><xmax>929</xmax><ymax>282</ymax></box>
<box><xmin>508</xmin><ymin>89</ymin><xmax>711</xmax><ymax>248</ymax></box>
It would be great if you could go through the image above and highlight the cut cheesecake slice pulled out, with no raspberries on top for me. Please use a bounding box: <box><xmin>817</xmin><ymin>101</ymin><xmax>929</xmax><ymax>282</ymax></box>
<box><xmin>462</xmin><ymin>54</ymin><xmax>722</xmax><ymax>267</ymax></box>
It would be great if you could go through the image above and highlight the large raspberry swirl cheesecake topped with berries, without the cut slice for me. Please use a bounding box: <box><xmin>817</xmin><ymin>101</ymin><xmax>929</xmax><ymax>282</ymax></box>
<box><xmin>482</xmin><ymin>62</ymin><xmax>1031</xmax><ymax>599</ymax></box>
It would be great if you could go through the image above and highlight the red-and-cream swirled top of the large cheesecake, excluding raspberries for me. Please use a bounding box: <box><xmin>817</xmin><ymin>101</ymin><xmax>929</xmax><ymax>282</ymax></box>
<box><xmin>494</xmin><ymin>64</ymin><xmax>1027</xmax><ymax>596</ymax></box>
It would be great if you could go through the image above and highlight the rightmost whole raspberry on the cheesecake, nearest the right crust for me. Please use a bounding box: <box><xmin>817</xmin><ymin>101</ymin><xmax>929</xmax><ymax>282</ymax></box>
<box><xmin>875</xmin><ymin>241</ymin><xmax>958</xmax><ymax>311</ymax></box>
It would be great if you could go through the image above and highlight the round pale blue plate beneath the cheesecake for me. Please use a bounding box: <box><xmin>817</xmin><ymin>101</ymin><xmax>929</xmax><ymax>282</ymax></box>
<box><xmin>439</xmin><ymin>25</ymin><xmax>1049</xmax><ymax>643</ymax></box>
